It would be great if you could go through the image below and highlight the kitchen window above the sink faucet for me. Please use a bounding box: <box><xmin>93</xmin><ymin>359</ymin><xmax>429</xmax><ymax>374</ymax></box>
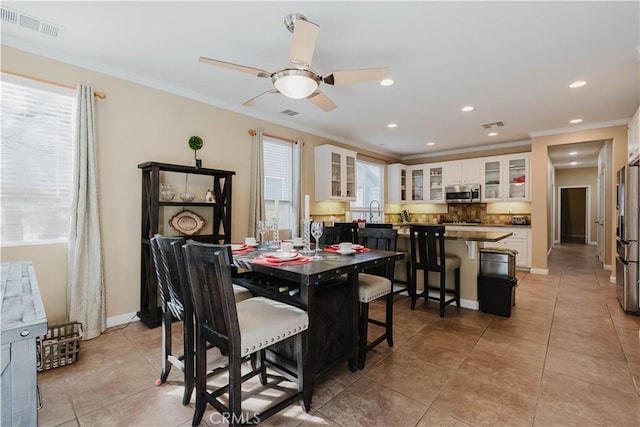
<box><xmin>351</xmin><ymin>160</ymin><xmax>384</xmax><ymax>222</ymax></box>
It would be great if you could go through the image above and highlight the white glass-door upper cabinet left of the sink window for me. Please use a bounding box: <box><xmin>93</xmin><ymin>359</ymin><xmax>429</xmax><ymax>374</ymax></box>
<box><xmin>315</xmin><ymin>144</ymin><xmax>357</xmax><ymax>201</ymax></box>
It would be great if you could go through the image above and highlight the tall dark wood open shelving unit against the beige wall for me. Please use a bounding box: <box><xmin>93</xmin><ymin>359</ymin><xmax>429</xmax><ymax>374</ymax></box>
<box><xmin>137</xmin><ymin>162</ymin><xmax>236</xmax><ymax>328</ymax></box>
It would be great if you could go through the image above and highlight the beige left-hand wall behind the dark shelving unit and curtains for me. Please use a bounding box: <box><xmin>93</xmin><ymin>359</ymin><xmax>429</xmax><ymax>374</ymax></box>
<box><xmin>0</xmin><ymin>46</ymin><xmax>397</xmax><ymax>321</ymax></box>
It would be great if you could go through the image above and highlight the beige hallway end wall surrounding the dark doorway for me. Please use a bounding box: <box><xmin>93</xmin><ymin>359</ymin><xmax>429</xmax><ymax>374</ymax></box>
<box><xmin>553</xmin><ymin>168</ymin><xmax>598</xmax><ymax>242</ymax></box>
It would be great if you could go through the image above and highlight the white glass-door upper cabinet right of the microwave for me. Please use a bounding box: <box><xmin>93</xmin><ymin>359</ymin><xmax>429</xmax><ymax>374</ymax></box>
<box><xmin>480</xmin><ymin>153</ymin><xmax>531</xmax><ymax>202</ymax></box>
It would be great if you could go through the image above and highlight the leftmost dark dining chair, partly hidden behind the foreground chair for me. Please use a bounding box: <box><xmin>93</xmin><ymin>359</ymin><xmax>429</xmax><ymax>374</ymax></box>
<box><xmin>151</xmin><ymin>234</ymin><xmax>253</xmax><ymax>405</ymax></box>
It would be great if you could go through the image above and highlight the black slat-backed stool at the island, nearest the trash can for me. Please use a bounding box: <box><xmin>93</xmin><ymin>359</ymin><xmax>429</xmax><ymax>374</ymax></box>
<box><xmin>409</xmin><ymin>225</ymin><xmax>461</xmax><ymax>317</ymax></box>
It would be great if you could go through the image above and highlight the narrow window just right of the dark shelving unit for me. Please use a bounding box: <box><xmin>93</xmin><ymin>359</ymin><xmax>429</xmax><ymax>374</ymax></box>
<box><xmin>262</xmin><ymin>137</ymin><xmax>295</xmax><ymax>229</ymax></box>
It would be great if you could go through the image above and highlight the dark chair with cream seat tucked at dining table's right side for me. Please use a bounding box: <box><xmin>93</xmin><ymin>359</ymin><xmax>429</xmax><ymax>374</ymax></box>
<box><xmin>358</xmin><ymin>227</ymin><xmax>398</xmax><ymax>369</ymax></box>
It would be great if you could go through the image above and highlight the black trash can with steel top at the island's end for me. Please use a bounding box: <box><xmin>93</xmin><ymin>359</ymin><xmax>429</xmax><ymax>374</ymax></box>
<box><xmin>478</xmin><ymin>248</ymin><xmax>518</xmax><ymax>317</ymax></box>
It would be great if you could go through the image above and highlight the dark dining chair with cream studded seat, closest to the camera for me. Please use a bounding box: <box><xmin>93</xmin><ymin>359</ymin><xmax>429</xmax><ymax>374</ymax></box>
<box><xmin>183</xmin><ymin>243</ymin><xmax>310</xmax><ymax>425</ymax></box>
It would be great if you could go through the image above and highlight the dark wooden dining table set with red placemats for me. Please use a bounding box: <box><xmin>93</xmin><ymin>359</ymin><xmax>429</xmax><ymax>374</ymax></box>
<box><xmin>233</xmin><ymin>245</ymin><xmax>405</xmax><ymax>408</ymax></box>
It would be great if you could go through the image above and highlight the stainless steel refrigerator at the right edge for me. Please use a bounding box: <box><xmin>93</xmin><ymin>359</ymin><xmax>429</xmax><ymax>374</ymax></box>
<box><xmin>616</xmin><ymin>162</ymin><xmax>640</xmax><ymax>315</ymax></box>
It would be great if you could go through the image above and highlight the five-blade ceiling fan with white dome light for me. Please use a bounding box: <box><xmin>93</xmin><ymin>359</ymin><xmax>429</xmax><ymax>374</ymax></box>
<box><xmin>199</xmin><ymin>13</ymin><xmax>389</xmax><ymax>111</ymax></box>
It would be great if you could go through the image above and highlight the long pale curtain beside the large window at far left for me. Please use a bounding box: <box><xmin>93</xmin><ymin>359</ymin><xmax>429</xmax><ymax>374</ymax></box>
<box><xmin>67</xmin><ymin>84</ymin><xmax>107</xmax><ymax>339</ymax></box>
